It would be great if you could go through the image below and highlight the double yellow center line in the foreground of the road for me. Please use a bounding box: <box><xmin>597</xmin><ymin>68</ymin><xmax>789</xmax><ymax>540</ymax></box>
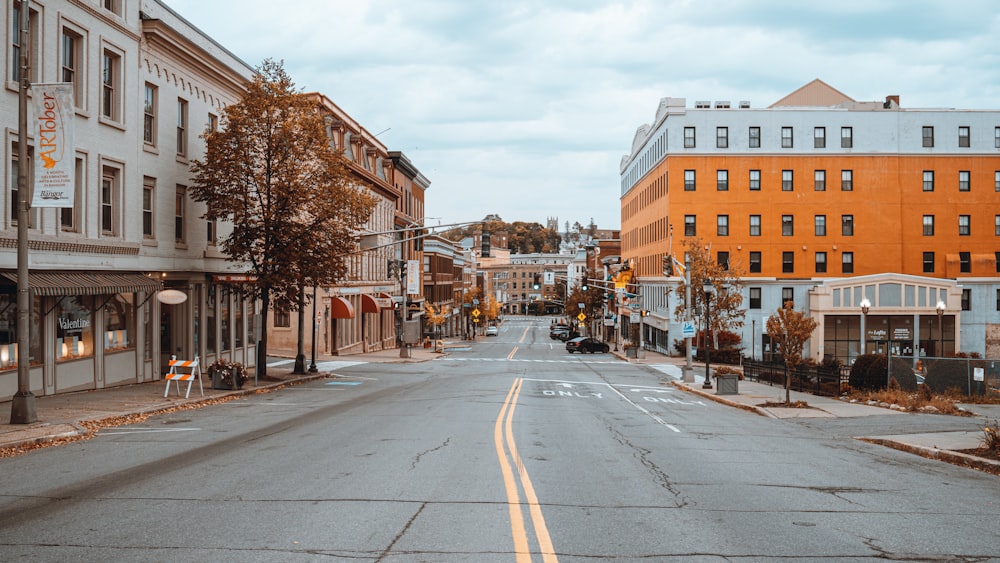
<box><xmin>493</xmin><ymin>378</ymin><xmax>559</xmax><ymax>563</ymax></box>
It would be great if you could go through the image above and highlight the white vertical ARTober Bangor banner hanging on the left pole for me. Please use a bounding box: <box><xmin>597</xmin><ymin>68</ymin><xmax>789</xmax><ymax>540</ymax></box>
<box><xmin>31</xmin><ymin>83</ymin><xmax>76</xmax><ymax>207</ymax></box>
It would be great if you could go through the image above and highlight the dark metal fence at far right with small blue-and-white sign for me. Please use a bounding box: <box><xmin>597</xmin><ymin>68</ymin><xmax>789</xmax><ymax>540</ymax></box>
<box><xmin>889</xmin><ymin>356</ymin><xmax>1000</xmax><ymax>396</ymax></box>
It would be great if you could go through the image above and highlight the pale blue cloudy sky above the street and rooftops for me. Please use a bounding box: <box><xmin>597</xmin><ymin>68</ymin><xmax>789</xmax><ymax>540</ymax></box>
<box><xmin>164</xmin><ymin>0</ymin><xmax>1000</xmax><ymax>228</ymax></box>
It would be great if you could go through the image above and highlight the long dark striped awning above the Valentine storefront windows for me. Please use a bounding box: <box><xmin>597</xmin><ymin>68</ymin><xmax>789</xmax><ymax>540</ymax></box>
<box><xmin>0</xmin><ymin>272</ymin><xmax>161</xmax><ymax>297</ymax></box>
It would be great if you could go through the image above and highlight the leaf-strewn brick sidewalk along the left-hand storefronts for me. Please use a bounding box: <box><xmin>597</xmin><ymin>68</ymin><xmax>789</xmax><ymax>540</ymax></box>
<box><xmin>0</xmin><ymin>342</ymin><xmax>451</xmax><ymax>457</ymax></box>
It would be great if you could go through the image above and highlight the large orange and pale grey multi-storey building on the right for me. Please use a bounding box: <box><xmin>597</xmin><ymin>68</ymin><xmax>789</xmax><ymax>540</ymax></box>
<box><xmin>621</xmin><ymin>80</ymin><xmax>1000</xmax><ymax>362</ymax></box>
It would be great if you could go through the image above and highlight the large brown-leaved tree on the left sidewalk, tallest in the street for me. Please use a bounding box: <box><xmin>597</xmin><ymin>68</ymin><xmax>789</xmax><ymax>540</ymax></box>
<box><xmin>190</xmin><ymin>59</ymin><xmax>374</xmax><ymax>376</ymax></box>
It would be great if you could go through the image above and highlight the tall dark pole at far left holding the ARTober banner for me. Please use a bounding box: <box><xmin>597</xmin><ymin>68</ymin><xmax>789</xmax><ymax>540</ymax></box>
<box><xmin>10</xmin><ymin>0</ymin><xmax>38</xmax><ymax>424</ymax></box>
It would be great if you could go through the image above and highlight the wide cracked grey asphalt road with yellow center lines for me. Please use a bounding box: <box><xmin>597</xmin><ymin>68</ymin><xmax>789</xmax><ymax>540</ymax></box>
<box><xmin>0</xmin><ymin>319</ymin><xmax>1000</xmax><ymax>562</ymax></box>
